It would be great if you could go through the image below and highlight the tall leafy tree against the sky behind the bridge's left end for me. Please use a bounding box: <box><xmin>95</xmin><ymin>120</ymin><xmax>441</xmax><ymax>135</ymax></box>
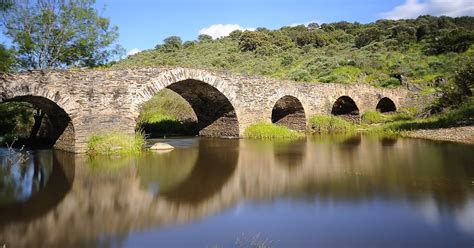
<box><xmin>2</xmin><ymin>0</ymin><xmax>123</xmax><ymax>70</ymax></box>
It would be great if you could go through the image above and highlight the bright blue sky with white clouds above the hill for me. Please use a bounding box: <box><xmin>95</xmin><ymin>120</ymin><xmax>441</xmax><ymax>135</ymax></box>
<box><xmin>0</xmin><ymin>0</ymin><xmax>474</xmax><ymax>54</ymax></box>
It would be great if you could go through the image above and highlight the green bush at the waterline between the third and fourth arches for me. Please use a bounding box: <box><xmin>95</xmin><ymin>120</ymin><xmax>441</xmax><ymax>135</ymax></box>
<box><xmin>308</xmin><ymin>115</ymin><xmax>355</xmax><ymax>134</ymax></box>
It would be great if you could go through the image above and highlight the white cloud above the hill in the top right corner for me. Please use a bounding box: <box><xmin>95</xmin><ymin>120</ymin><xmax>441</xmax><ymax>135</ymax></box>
<box><xmin>382</xmin><ymin>0</ymin><xmax>474</xmax><ymax>20</ymax></box>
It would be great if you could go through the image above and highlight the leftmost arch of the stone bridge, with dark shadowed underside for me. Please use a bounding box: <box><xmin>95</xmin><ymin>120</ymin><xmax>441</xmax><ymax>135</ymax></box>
<box><xmin>0</xmin><ymin>93</ymin><xmax>75</xmax><ymax>152</ymax></box>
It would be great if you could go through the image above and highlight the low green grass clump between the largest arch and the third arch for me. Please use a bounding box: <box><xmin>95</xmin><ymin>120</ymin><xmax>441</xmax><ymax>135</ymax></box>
<box><xmin>244</xmin><ymin>122</ymin><xmax>304</xmax><ymax>139</ymax></box>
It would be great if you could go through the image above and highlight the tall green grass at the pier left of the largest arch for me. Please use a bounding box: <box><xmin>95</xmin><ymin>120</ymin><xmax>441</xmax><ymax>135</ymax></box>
<box><xmin>87</xmin><ymin>131</ymin><xmax>145</xmax><ymax>155</ymax></box>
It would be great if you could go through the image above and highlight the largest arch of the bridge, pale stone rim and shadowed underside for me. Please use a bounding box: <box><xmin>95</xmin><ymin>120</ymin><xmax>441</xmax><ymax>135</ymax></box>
<box><xmin>134</xmin><ymin>68</ymin><xmax>240</xmax><ymax>137</ymax></box>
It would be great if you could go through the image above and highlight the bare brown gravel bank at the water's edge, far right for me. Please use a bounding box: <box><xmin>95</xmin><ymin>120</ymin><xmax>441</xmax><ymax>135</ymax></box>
<box><xmin>405</xmin><ymin>126</ymin><xmax>474</xmax><ymax>144</ymax></box>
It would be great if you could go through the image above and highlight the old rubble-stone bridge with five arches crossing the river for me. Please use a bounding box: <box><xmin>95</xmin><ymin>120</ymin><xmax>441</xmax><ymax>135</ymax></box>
<box><xmin>0</xmin><ymin>68</ymin><xmax>420</xmax><ymax>153</ymax></box>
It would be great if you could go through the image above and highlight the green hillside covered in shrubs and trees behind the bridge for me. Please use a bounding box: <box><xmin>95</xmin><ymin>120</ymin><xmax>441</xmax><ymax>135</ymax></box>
<box><xmin>113</xmin><ymin>16</ymin><xmax>474</xmax><ymax>87</ymax></box>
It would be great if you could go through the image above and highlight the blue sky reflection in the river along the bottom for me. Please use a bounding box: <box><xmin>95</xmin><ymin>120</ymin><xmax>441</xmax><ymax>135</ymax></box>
<box><xmin>124</xmin><ymin>199</ymin><xmax>474</xmax><ymax>247</ymax></box>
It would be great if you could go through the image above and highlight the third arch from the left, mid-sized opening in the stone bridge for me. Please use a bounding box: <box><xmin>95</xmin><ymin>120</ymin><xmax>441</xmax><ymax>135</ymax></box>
<box><xmin>272</xmin><ymin>95</ymin><xmax>306</xmax><ymax>131</ymax></box>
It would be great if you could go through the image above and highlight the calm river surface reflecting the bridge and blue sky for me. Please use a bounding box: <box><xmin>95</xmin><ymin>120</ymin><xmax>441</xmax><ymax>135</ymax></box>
<box><xmin>0</xmin><ymin>136</ymin><xmax>474</xmax><ymax>248</ymax></box>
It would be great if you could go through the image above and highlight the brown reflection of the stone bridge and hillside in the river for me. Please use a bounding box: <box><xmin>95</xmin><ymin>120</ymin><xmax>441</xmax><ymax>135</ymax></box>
<box><xmin>0</xmin><ymin>136</ymin><xmax>474</xmax><ymax>247</ymax></box>
